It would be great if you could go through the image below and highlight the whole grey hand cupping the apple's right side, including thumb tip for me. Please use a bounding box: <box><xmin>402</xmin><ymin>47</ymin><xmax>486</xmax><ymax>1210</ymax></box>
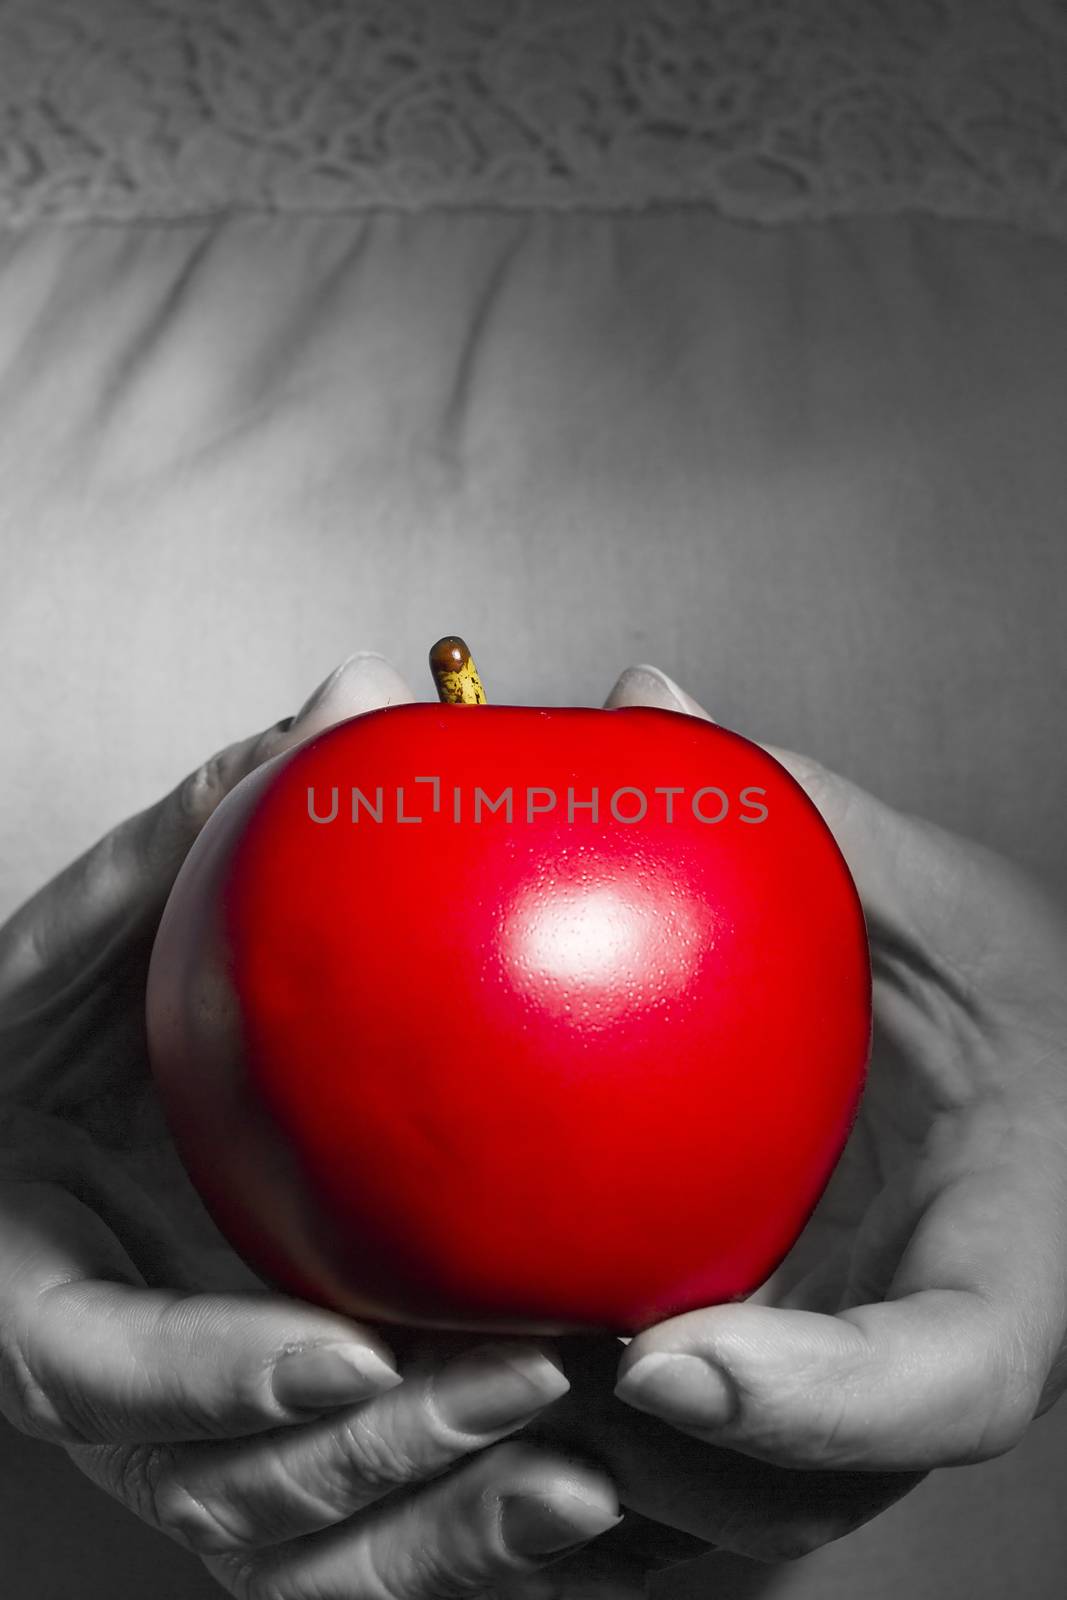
<box><xmin>559</xmin><ymin>667</ymin><xmax>1067</xmax><ymax>1557</ymax></box>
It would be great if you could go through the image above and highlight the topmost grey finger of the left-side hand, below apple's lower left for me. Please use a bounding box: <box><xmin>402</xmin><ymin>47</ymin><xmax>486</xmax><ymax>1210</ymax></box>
<box><xmin>0</xmin><ymin>1182</ymin><xmax>400</xmax><ymax>1443</ymax></box>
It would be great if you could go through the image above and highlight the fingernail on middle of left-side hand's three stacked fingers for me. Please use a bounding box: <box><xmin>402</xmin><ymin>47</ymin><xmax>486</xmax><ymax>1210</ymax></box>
<box><xmin>434</xmin><ymin>1344</ymin><xmax>571</xmax><ymax>1434</ymax></box>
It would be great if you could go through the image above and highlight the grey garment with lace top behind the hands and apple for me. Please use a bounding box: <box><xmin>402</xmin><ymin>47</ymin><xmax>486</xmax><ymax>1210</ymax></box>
<box><xmin>0</xmin><ymin>0</ymin><xmax>1067</xmax><ymax>1600</ymax></box>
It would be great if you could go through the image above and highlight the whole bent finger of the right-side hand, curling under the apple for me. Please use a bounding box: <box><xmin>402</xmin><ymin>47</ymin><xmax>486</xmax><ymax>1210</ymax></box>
<box><xmin>616</xmin><ymin>1110</ymin><xmax>1067</xmax><ymax>1470</ymax></box>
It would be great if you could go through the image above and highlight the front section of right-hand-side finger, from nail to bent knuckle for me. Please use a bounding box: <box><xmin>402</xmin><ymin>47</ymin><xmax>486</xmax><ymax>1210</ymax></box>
<box><xmin>616</xmin><ymin>1260</ymin><xmax>1048</xmax><ymax>1472</ymax></box>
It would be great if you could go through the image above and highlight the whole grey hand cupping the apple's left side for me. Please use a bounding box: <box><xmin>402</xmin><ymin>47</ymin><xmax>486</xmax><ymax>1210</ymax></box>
<box><xmin>0</xmin><ymin>656</ymin><xmax>619</xmax><ymax>1600</ymax></box>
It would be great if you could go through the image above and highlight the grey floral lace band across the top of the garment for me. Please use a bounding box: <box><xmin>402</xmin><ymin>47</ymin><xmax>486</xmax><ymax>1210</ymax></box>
<box><xmin>0</xmin><ymin>0</ymin><xmax>1067</xmax><ymax>235</ymax></box>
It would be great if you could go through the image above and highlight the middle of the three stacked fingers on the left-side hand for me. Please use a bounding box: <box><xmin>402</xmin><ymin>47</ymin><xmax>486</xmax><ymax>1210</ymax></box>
<box><xmin>134</xmin><ymin>1339</ymin><xmax>568</xmax><ymax>1554</ymax></box>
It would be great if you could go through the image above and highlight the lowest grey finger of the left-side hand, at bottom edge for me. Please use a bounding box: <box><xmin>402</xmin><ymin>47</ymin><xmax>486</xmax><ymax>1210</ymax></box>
<box><xmin>206</xmin><ymin>1440</ymin><xmax>621</xmax><ymax>1600</ymax></box>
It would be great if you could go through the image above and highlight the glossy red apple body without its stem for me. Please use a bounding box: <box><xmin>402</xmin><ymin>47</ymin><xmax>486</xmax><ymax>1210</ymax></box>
<box><xmin>147</xmin><ymin>704</ymin><xmax>870</xmax><ymax>1334</ymax></box>
